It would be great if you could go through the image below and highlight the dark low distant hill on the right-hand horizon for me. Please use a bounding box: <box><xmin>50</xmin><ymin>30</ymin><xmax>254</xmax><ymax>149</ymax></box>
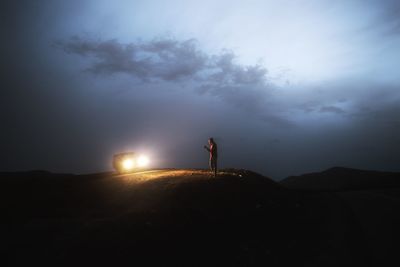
<box><xmin>280</xmin><ymin>167</ymin><xmax>400</xmax><ymax>191</ymax></box>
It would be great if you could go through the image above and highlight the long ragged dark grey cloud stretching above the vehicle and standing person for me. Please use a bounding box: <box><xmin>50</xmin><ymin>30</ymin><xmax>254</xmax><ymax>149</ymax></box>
<box><xmin>56</xmin><ymin>36</ymin><xmax>267</xmax><ymax>87</ymax></box>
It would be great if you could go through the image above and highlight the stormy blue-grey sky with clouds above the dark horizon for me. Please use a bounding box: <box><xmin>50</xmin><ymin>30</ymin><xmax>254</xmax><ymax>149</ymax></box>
<box><xmin>0</xmin><ymin>0</ymin><xmax>400</xmax><ymax>180</ymax></box>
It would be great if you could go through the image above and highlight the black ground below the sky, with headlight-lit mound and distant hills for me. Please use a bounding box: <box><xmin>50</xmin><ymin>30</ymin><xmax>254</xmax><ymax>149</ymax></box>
<box><xmin>0</xmin><ymin>168</ymin><xmax>400</xmax><ymax>266</ymax></box>
